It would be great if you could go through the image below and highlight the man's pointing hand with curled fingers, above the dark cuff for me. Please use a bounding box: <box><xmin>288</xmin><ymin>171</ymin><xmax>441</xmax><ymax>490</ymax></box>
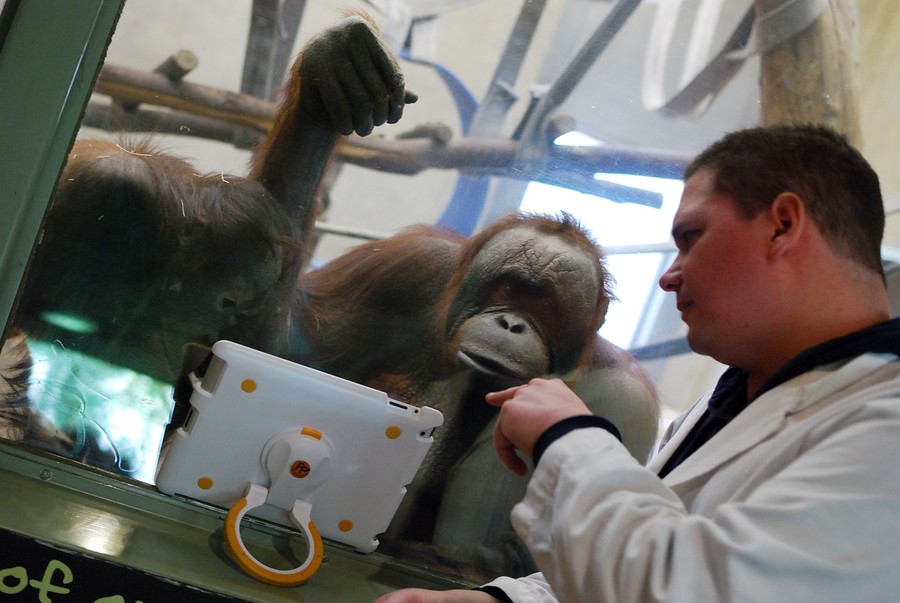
<box><xmin>485</xmin><ymin>379</ymin><xmax>591</xmax><ymax>475</ymax></box>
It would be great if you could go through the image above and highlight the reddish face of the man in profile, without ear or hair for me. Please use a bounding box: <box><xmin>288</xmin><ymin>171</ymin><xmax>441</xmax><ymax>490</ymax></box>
<box><xmin>659</xmin><ymin>169</ymin><xmax>771</xmax><ymax>368</ymax></box>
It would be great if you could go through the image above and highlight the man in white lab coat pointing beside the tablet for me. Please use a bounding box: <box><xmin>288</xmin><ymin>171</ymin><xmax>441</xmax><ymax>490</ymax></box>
<box><xmin>380</xmin><ymin>126</ymin><xmax>900</xmax><ymax>603</ymax></box>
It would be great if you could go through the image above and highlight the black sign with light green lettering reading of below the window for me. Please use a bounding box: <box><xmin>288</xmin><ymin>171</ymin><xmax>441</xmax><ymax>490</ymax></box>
<box><xmin>0</xmin><ymin>529</ymin><xmax>246</xmax><ymax>603</ymax></box>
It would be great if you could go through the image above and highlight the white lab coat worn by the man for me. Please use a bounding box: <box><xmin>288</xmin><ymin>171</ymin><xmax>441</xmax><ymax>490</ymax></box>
<box><xmin>491</xmin><ymin>354</ymin><xmax>900</xmax><ymax>603</ymax></box>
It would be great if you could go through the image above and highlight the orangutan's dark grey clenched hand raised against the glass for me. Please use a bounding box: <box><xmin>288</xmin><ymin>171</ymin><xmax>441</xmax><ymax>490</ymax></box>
<box><xmin>299</xmin><ymin>16</ymin><xmax>417</xmax><ymax>136</ymax></box>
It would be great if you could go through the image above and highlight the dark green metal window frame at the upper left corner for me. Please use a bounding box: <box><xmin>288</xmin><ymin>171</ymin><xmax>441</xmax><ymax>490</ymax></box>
<box><xmin>0</xmin><ymin>0</ymin><xmax>125</xmax><ymax>326</ymax></box>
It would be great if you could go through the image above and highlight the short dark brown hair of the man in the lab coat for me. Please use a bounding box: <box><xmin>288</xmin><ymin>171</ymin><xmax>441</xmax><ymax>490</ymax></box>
<box><xmin>685</xmin><ymin>125</ymin><xmax>884</xmax><ymax>274</ymax></box>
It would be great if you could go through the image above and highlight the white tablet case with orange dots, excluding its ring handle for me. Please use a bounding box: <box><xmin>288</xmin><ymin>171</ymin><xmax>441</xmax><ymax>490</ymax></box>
<box><xmin>156</xmin><ymin>341</ymin><xmax>443</xmax><ymax>552</ymax></box>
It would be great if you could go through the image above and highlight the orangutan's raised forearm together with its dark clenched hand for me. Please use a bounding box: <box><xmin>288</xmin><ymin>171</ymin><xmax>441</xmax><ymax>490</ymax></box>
<box><xmin>250</xmin><ymin>15</ymin><xmax>416</xmax><ymax>242</ymax></box>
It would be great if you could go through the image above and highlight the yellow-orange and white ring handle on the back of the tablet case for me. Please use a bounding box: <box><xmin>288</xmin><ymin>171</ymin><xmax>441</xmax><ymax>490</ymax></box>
<box><xmin>225</xmin><ymin>484</ymin><xmax>324</xmax><ymax>586</ymax></box>
